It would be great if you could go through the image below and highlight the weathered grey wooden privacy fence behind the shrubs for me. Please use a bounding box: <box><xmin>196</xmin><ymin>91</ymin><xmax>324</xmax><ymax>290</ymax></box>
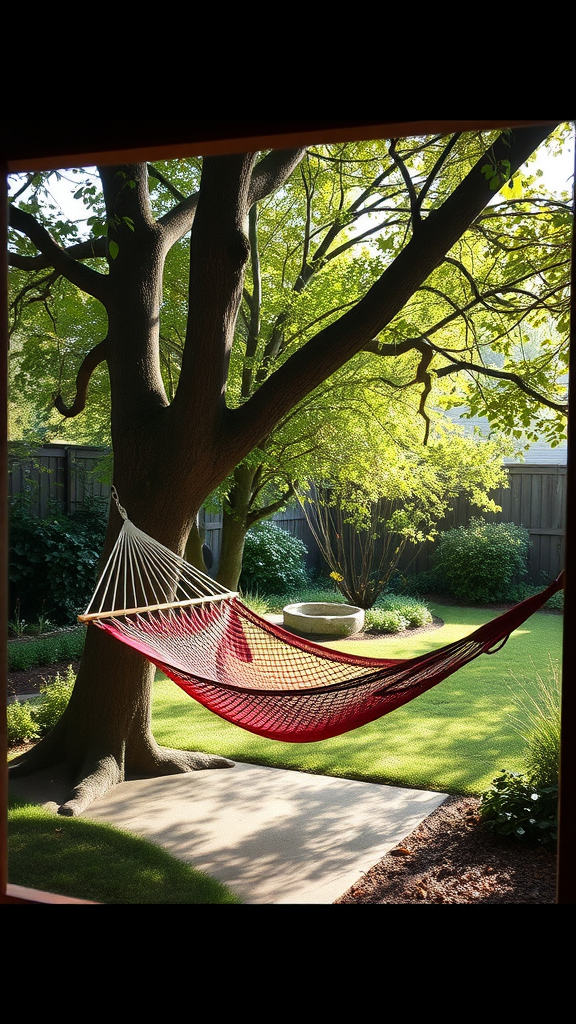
<box><xmin>8</xmin><ymin>444</ymin><xmax>567</xmax><ymax>584</ymax></box>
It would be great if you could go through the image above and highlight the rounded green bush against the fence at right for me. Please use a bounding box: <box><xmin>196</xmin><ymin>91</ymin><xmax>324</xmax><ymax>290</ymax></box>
<box><xmin>434</xmin><ymin>519</ymin><xmax>530</xmax><ymax>604</ymax></box>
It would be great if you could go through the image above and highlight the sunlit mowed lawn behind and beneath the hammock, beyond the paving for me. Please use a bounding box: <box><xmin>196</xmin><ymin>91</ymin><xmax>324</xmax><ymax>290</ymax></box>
<box><xmin>148</xmin><ymin>605</ymin><xmax>563</xmax><ymax>795</ymax></box>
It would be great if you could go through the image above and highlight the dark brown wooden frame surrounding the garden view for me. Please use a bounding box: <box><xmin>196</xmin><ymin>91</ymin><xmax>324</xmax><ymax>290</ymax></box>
<box><xmin>0</xmin><ymin>118</ymin><xmax>576</xmax><ymax>904</ymax></box>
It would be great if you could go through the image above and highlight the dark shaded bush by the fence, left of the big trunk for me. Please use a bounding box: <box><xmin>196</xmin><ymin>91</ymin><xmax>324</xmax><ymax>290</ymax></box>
<box><xmin>8</xmin><ymin>499</ymin><xmax>107</xmax><ymax>632</ymax></box>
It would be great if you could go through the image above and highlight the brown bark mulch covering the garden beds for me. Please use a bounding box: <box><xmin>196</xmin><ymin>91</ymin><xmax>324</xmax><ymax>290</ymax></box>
<box><xmin>8</xmin><ymin>621</ymin><xmax>557</xmax><ymax>904</ymax></box>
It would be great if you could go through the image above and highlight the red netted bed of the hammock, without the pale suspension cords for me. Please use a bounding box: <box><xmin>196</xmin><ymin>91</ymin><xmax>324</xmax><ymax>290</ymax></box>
<box><xmin>90</xmin><ymin>573</ymin><xmax>564</xmax><ymax>742</ymax></box>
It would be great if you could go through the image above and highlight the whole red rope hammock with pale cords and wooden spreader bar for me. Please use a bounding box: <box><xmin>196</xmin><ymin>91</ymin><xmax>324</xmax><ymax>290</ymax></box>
<box><xmin>79</xmin><ymin>506</ymin><xmax>563</xmax><ymax>742</ymax></box>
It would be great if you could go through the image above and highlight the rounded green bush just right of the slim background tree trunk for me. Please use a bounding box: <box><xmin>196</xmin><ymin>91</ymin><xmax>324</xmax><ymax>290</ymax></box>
<box><xmin>240</xmin><ymin>521</ymin><xmax>308</xmax><ymax>594</ymax></box>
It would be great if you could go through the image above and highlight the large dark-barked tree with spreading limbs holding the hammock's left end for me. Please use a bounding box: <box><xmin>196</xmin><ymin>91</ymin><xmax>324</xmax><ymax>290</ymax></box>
<box><xmin>10</xmin><ymin>127</ymin><xmax>560</xmax><ymax>814</ymax></box>
